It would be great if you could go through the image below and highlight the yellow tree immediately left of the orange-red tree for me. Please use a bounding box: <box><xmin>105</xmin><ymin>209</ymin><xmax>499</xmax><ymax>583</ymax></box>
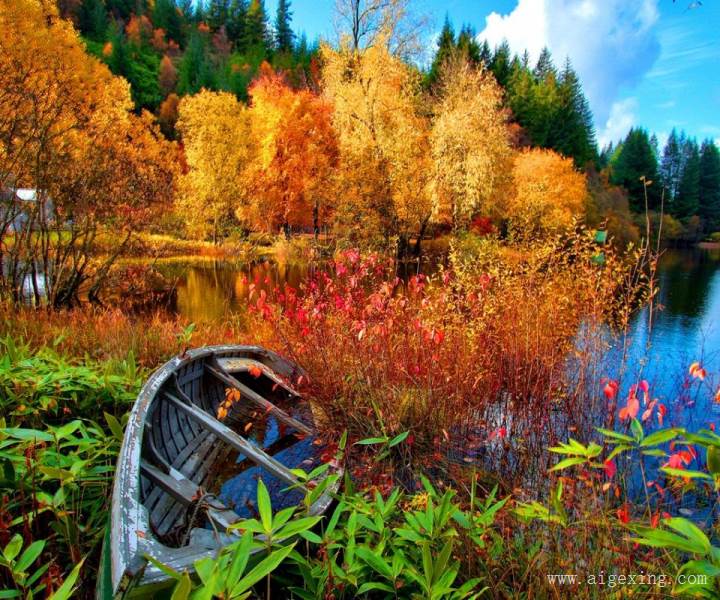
<box><xmin>176</xmin><ymin>90</ymin><xmax>254</xmax><ymax>241</ymax></box>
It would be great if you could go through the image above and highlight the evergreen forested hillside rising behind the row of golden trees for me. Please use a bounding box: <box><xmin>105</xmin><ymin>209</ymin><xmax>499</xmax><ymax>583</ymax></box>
<box><xmin>53</xmin><ymin>0</ymin><xmax>720</xmax><ymax>241</ymax></box>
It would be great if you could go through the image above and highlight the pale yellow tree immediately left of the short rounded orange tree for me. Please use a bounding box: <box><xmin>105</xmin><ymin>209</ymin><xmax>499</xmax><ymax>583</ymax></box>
<box><xmin>430</xmin><ymin>58</ymin><xmax>512</xmax><ymax>228</ymax></box>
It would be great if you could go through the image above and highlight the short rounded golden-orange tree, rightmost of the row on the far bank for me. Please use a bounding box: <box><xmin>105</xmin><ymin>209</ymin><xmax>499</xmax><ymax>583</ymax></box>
<box><xmin>504</xmin><ymin>148</ymin><xmax>588</xmax><ymax>237</ymax></box>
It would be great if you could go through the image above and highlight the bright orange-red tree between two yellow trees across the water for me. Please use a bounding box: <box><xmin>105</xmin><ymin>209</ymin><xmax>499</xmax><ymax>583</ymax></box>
<box><xmin>249</xmin><ymin>64</ymin><xmax>337</xmax><ymax>234</ymax></box>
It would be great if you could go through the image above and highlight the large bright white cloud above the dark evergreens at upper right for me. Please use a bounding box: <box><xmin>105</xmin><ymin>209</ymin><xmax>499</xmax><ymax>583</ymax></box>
<box><xmin>478</xmin><ymin>0</ymin><xmax>660</xmax><ymax>128</ymax></box>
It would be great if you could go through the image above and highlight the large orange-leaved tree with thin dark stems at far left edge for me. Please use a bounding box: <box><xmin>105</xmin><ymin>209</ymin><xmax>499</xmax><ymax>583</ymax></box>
<box><xmin>0</xmin><ymin>0</ymin><xmax>176</xmax><ymax>306</ymax></box>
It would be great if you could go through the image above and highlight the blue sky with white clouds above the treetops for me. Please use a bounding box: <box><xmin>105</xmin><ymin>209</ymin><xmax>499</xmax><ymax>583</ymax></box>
<box><xmin>266</xmin><ymin>0</ymin><xmax>720</xmax><ymax>149</ymax></box>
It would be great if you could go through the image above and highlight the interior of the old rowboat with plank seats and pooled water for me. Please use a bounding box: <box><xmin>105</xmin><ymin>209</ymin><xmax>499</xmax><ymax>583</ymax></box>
<box><xmin>140</xmin><ymin>356</ymin><xmax>320</xmax><ymax>547</ymax></box>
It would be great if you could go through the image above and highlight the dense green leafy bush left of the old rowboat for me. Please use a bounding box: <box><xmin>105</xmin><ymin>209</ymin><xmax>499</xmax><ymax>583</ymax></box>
<box><xmin>0</xmin><ymin>337</ymin><xmax>141</xmax><ymax>599</ymax></box>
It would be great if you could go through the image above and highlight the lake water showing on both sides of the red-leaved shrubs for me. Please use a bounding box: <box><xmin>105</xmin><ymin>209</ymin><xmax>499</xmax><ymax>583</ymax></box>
<box><xmin>158</xmin><ymin>248</ymin><xmax>720</xmax><ymax>427</ymax></box>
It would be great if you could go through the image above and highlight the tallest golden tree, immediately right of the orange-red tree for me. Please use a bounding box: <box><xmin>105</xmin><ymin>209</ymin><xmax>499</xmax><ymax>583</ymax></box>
<box><xmin>321</xmin><ymin>41</ymin><xmax>431</xmax><ymax>251</ymax></box>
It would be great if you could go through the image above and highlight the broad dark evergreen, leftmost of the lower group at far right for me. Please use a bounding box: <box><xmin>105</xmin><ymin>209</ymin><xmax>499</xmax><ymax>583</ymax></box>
<box><xmin>610</xmin><ymin>128</ymin><xmax>660</xmax><ymax>212</ymax></box>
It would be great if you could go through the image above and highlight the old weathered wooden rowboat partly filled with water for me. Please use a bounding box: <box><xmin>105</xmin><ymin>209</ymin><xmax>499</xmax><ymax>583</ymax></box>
<box><xmin>97</xmin><ymin>346</ymin><xmax>340</xmax><ymax>600</ymax></box>
